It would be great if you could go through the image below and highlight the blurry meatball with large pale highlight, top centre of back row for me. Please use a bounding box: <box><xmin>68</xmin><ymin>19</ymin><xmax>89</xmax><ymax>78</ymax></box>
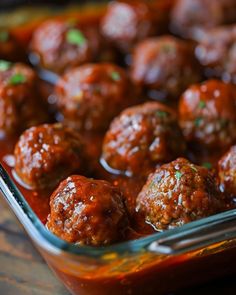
<box><xmin>101</xmin><ymin>0</ymin><xmax>170</xmax><ymax>52</ymax></box>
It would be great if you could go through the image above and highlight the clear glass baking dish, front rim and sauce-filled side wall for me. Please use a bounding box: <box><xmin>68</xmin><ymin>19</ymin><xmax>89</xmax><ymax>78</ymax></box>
<box><xmin>0</xmin><ymin>1</ymin><xmax>236</xmax><ymax>295</ymax></box>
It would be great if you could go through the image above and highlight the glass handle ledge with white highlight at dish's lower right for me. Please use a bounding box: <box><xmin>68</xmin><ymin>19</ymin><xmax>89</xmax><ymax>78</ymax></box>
<box><xmin>148</xmin><ymin>209</ymin><xmax>236</xmax><ymax>255</ymax></box>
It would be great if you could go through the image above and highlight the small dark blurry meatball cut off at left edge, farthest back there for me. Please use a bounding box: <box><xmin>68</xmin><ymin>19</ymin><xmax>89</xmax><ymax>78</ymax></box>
<box><xmin>0</xmin><ymin>29</ymin><xmax>26</xmax><ymax>61</ymax></box>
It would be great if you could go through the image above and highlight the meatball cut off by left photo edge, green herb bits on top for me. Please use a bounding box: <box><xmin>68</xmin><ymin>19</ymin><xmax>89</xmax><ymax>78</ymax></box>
<box><xmin>0</xmin><ymin>60</ymin><xmax>47</xmax><ymax>137</ymax></box>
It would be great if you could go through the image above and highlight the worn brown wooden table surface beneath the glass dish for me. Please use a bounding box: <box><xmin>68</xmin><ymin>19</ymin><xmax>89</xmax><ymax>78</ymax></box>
<box><xmin>0</xmin><ymin>196</ymin><xmax>236</xmax><ymax>295</ymax></box>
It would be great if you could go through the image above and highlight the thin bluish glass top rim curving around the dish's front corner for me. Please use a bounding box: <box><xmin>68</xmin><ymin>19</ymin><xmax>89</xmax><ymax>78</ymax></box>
<box><xmin>0</xmin><ymin>164</ymin><xmax>236</xmax><ymax>258</ymax></box>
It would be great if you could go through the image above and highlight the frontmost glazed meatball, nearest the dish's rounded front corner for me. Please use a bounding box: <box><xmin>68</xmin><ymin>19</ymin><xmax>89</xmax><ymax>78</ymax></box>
<box><xmin>46</xmin><ymin>175</ymin><xmax>128</xmax><ymax>246</ymax></box>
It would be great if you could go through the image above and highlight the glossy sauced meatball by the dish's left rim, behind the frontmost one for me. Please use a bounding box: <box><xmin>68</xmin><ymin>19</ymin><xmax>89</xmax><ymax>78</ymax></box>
<box><xmin>14</xmin><ymin>123</ymin><xmax>86</xmax><ymax>189</ymax></box>
